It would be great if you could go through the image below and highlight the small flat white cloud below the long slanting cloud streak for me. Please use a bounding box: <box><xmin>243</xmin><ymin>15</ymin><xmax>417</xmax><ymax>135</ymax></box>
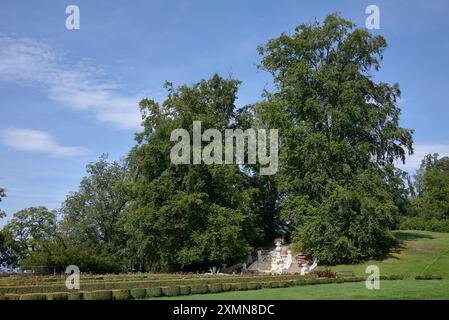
<box><xmin>0</xmin><ymin>128</ymin><xmax>89</xmax><ymax>157</ymax></box>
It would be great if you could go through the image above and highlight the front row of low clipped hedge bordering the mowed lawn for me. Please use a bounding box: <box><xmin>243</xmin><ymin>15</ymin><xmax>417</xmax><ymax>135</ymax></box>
<box><xmin>0</xmin><ymin>277</ymin><xmax>374</xmax><ymax>300</ymax></box>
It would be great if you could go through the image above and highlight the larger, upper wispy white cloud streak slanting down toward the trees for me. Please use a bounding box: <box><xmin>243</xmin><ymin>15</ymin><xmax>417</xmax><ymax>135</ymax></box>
<box><xmin>0</xmin><ymin>35</ymin><xmax>142</xmax><ymax>129</ymax></box>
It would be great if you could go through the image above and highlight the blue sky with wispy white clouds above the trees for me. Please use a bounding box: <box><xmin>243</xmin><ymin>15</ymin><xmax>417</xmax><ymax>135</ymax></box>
<box><xmin>0</xmin><ymin>0</ymin><xmax>449</xmax><ymax>225</ymax></box>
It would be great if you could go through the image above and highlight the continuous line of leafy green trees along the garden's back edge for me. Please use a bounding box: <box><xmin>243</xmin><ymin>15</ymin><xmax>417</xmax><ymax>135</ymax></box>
<box><xmin>0</xmin><ymin>14</ymin><xmax>449</xmax><ymax>272</ymax></box>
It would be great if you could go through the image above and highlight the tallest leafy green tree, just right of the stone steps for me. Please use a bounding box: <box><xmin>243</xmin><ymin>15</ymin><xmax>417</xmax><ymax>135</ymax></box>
<box><xmin>255</xmin><ymin>15</ymin><xmax>412</xmax><ymax>263</ymax></box>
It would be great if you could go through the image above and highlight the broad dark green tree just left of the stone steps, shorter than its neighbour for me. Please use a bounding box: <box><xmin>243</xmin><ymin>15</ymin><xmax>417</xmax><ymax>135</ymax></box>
<box><xmin>125</xmin><ymin>75</ymin><xmax>258</xmax><ymax>271</ymax></box>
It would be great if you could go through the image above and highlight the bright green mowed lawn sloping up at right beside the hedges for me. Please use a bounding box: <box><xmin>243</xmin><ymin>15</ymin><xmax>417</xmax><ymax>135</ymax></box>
<box><xmin>149</xmin><ymin>231</ymin><xmax>449</xmax><ymax>300</ymax></box>
